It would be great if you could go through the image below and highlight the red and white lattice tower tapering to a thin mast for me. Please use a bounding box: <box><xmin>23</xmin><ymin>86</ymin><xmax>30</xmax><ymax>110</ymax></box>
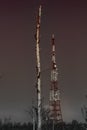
<box><xmin>50</xmin><ymin>34</ymin><xmax>63</xmax><ymax>122</ymax></box>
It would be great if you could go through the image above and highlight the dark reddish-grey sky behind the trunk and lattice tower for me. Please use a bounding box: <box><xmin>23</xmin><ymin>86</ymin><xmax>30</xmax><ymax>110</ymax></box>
<box><xmin>0</xmin><ymin>0</ymin><xmax>87</xmax><ymax>122</ymax></box>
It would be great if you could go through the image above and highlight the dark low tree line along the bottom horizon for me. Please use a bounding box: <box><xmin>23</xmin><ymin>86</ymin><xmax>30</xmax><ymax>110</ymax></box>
<box><xmin>0</xmin><ymin>120</ymin><xmax>87</xmax><ymax>130</ymax></box>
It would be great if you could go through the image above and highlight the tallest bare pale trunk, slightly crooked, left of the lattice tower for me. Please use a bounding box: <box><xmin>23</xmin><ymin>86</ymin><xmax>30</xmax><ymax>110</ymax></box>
<box><xmin>35</xmin><ymin>5</ymin><xmax>41</xmax><ymax>130</ymax></box>
